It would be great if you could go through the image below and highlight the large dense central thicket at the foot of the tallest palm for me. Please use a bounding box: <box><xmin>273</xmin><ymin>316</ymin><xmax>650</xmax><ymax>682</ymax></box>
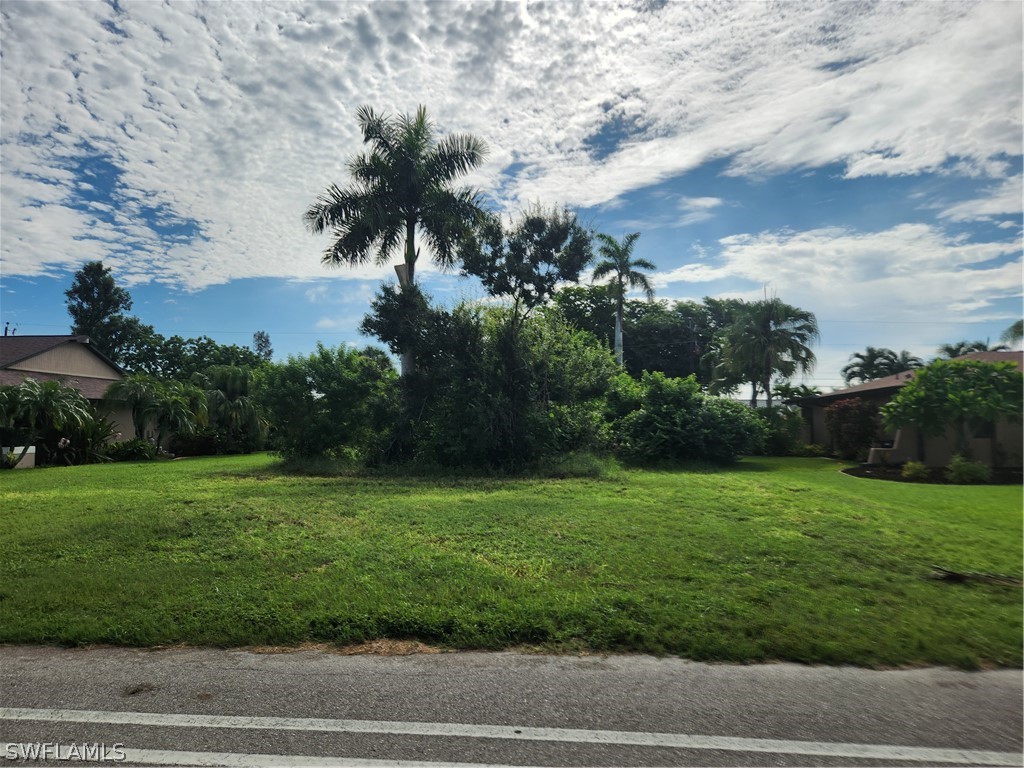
<box><xmin>362</xmin><ymin>286</ymin><xmax>615</xmax><ymax>471</ymax></box>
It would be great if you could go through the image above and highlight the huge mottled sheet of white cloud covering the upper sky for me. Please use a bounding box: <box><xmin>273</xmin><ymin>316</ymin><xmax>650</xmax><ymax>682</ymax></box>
<box><xmin>0</xmin><ymin>0</ymin><xmax>1022</xmax><ymax>290</ymax></box>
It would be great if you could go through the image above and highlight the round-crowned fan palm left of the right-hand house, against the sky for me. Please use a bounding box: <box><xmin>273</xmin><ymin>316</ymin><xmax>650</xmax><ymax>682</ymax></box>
<box><xmin>722</xmin><ymin>297</ymin><xmax>819</xmax><ymax>408</ymax></box>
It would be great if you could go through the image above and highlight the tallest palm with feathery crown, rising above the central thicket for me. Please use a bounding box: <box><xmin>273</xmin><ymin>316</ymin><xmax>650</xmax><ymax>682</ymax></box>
<box><xmin>305</xmin><ymin>106</ymin><xmax>487</xmax><ymax>375</ymax></box>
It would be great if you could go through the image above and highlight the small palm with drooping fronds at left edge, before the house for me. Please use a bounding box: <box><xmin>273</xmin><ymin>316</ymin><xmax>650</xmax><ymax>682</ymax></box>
<box><xmin>0</xmin><ymin>379</ymin><xmax>92</xmax><ymax>466</ymax></box>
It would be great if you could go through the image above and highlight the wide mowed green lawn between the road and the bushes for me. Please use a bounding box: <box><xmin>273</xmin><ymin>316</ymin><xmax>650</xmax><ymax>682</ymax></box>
<box><xmin>0</xmin><ymin>455</ymin><xmax>1022</xmax><ymax>668</ymax></box>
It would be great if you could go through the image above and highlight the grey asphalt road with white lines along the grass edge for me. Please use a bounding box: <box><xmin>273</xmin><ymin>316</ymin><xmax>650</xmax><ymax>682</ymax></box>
<box><xmin>0</xmin><ymin>646</ymin><xmax>1024</xmax><ymax>766</ymax></box>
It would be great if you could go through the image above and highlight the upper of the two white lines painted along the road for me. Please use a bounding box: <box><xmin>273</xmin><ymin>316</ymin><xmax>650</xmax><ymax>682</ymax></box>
<box><xmin>0</xmin><ymin>708</ymin><xmax>1024</xmax><ymax>766</ymax></box>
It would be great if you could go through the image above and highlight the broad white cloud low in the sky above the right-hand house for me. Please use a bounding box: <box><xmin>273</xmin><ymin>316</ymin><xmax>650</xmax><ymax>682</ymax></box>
<box><xmin>653</xmin><ymin>224</ymin><xmax>1021</xmax><ymax>323</ymax></box>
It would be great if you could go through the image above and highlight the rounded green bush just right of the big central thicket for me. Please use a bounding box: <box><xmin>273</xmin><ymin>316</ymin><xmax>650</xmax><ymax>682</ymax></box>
<box><xmin>607</xmin><ymin>373</ymin><xmax>766</xmax><ymax>463</ymax></box>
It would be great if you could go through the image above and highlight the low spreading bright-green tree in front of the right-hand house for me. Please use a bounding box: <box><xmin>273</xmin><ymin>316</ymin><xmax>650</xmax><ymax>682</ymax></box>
<box><xmin>882</xmin><ymin>359</ymin><xmax>1024</xmax><ymax>458</ymax></box>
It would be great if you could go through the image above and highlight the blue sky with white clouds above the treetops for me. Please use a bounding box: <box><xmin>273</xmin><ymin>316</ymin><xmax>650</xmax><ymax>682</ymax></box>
<box><xmin>0</xmin><ymin>0</ymin><xmax>1024</xmax><ymax>391</ymax></box>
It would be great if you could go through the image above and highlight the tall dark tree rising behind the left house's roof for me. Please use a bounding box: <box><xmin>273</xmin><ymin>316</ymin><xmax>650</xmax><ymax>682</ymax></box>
<box><xmin>65</xmin><ymin>261</ymin><xmax>132</xmax><ymax>362</ymax></box>
